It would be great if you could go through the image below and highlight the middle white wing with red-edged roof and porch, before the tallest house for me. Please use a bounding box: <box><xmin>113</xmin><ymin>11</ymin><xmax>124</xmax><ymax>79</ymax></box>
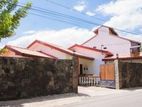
<box><xmin>69</xmin><ymin>44</ymin><xmax>112</xmax><ymax>76</ymax></box>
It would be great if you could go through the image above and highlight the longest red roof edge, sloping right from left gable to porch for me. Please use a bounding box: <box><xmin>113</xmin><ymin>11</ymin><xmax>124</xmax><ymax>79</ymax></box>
<box><xmin>27</xmin><ymin>40</ymin><xmax>94</xmax><ymax>60</ymax></box>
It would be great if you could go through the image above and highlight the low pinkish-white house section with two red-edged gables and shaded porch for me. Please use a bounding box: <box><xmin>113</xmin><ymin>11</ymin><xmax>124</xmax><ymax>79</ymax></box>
<box><xmin>27</xmin><ymin>40</ymin><xmax>112</xmax><ymax>75</ymax></box>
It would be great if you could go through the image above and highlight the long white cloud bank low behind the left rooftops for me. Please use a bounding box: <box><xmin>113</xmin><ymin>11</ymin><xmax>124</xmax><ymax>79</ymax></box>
<box><xmin>8</xmin><ymin>27</ymin><xmax>94</xmax><ymax>47</ymax></box>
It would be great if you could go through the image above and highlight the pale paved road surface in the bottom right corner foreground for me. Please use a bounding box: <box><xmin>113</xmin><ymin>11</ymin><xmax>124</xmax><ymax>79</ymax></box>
<box><xmin>62</xmin><ymin>90</ymin><xmax>142</xmax><ymax>107</ymax></box>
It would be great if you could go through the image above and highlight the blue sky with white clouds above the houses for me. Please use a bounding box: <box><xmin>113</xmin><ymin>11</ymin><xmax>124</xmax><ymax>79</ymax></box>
<box><xmin>0</xmin><ymin>0</ymin><xmax>142</xmax><ymax>47</ymax></box>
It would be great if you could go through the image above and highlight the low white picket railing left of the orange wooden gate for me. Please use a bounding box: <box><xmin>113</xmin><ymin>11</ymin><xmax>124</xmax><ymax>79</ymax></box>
<box><xmin>78</xmin><ymin>75</ymin><xmax>98</xmax><ymax>86</ymax></box>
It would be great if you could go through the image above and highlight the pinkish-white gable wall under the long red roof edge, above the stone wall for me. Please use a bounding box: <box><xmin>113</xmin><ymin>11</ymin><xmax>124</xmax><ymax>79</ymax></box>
<box><xmin>29</xmin><ymin>42</ymin><xmax>72</xmax><ymax>59</ymax></box>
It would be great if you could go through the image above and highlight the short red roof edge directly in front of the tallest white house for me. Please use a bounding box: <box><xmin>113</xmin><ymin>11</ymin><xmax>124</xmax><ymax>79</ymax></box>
<box><xmin>69</xmin><ymin>44</ymin><xmax>113</xmax><ymax>56</ymax></box>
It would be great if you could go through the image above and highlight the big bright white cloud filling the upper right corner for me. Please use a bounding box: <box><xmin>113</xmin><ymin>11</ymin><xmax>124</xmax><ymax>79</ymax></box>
<box><xmin>97</xmin><ymin>0</ymin><xmax>142</xmax><ymax>30</ymax></box>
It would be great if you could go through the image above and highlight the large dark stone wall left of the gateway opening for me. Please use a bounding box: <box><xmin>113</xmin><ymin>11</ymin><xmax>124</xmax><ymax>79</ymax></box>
<box><xmin>0</xmin><ymin>57</ymin><xmax>78</xmax><ymax>100</ymax></box>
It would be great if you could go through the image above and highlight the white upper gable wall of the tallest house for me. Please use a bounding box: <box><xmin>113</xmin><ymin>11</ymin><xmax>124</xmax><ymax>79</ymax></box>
<box><xmin>83</xmin><ymin>27</ymin><xmax>131</xmax><ymax>56</ymax></box>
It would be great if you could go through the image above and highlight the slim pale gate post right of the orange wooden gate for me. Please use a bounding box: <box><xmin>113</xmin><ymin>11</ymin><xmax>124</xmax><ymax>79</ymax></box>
<box><xmin>114</xmin><ymin>59</ymin><xmax>120</xmax><ymax>89</ymax></box>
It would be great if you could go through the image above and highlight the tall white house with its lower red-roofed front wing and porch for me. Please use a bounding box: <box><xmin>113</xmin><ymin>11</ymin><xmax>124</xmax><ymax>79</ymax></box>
<box><xmin>69</xmin><ymin>26</ymin><xmax>141</xmax><ymax>75</ymax></box>
